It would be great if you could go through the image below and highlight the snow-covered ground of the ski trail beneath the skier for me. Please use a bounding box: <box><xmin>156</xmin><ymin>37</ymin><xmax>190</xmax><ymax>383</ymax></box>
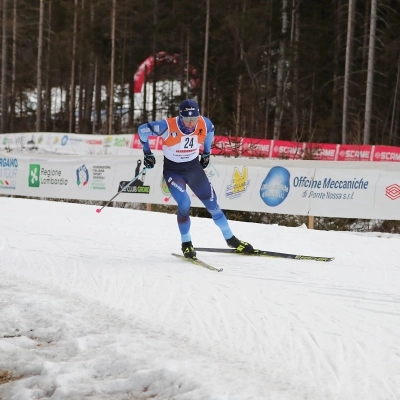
<box><xmin>0</xmin><ymin>198</ymin><xmax>400</xmax><ymax>400</ymax></box>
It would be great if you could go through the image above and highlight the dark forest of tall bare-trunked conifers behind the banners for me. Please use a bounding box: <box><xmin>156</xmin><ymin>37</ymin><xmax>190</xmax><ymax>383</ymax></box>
<box><xmin>0</xmin><ymin>0</ymin><xmax>400</xmax><ymax>146</ymax></box>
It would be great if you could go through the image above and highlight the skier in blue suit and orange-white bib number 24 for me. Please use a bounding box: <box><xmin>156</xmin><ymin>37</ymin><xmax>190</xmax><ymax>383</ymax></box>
<box><xmin>138</xmin><ymin>99</ymin><xmax>254</xmax><ymax>258</ymax></box>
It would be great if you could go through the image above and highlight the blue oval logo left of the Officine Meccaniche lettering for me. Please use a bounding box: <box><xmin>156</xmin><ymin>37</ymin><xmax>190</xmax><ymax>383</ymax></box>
<box><xmin>260</xmin><ymin>167</ymin><xmax>290</xmax><ymax>207</ymax></box>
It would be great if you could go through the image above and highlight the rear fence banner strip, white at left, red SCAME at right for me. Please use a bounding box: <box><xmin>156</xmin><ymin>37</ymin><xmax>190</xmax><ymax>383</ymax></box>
<box><xmin>0</xmin><ymin>132</ymin><xmax>400</xmax><ymax>162</ymax></box>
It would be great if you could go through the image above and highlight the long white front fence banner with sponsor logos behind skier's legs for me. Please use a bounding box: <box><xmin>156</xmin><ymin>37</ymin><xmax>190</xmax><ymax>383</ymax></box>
<box><xmin>0</xmin><ymin>153</ymin><xmax>400</xmax><ymax>220</ymax></box>
